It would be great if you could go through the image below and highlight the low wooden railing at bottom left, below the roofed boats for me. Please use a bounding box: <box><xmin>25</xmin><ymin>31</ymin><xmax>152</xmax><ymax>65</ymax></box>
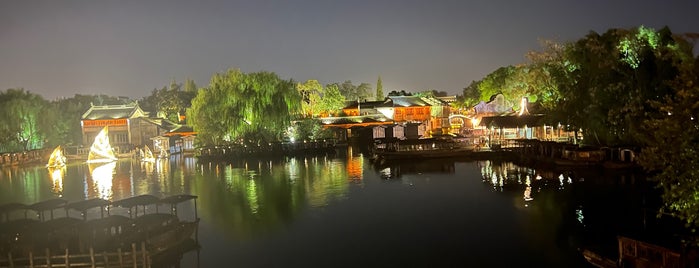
<box><xmin>0</xmin><ymin>242</ymin><xmax>151</xmax><ymax>268</ymax></box>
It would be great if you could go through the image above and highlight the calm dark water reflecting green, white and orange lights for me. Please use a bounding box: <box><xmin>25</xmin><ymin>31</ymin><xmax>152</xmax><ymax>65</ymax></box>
<box><xmin>0</xmin><ymin>147</ymin><xmax>668</xmax><ymax>267</ymax></box>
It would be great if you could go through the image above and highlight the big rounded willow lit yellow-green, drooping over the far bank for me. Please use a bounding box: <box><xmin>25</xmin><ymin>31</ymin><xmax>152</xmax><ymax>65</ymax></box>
<box><xmin>189</xmin><ymin>70</ymin><xmax>301</xmax><ymax>145</ymax></box>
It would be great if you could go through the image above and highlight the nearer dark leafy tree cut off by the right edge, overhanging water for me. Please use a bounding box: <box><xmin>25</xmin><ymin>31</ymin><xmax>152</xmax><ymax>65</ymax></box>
<box><xmin>639</xmin><ymin>48</ymin><xmax>699</xmax><ymax>228</ymax></box>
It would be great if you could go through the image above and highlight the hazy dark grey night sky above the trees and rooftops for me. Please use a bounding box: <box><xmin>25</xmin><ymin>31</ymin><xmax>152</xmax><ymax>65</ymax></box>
<box><xmin>0</xmin><ymin>0</ymin><xmax>699</xmax><ymax>99</ymax></box>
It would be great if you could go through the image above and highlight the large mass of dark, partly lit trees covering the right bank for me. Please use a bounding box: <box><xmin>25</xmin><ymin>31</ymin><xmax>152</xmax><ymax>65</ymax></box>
<box><xmin>459</xmin><ymin>26</ymin><xmax>699</xmax><ymax>230</ymax></box>
